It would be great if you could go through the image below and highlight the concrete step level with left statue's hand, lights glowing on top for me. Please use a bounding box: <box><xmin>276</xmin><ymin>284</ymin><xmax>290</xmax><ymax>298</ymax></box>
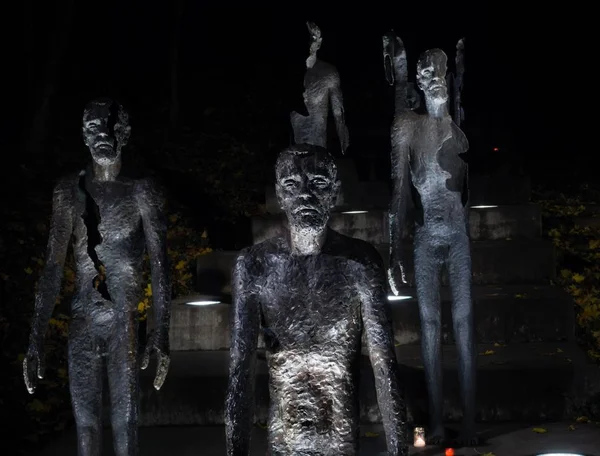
<box><xmin>170</xmin><ymin>285</ymin><xmax>574</xmax><ymax>351</ymax></box>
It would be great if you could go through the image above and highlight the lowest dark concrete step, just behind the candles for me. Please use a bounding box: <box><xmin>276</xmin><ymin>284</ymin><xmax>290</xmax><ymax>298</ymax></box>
<box><xmin>135</xmin><ymin>342</ymin><xmax>598</xmax><ymax>426</ymax></box>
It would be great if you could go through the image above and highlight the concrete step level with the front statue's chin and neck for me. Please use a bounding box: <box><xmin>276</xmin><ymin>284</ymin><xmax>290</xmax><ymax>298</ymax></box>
<box><xmin>252</xmin><ymin>204</ymin><xmax>542</xmax><ymax>244</ymax></box>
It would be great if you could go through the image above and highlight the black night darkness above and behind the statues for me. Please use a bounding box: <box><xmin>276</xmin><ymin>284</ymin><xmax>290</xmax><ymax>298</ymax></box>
<box><xmin>0</xmin><ymin>0</ymin><xmax>596</xmax><ymax>452</ymax></box>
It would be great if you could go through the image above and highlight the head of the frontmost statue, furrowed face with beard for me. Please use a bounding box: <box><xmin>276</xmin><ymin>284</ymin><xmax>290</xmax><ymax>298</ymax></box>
<box><xmin>275</xmin><ymin>144</ymin><xmax>340</xmax><ymax>230</ymax></box>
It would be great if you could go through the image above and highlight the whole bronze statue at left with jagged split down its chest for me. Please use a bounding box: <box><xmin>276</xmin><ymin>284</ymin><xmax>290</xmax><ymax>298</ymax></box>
<box><xmin>23</xmin><ymin>99</ymin><xmax>171</xmax><ymax>456</ymax></box>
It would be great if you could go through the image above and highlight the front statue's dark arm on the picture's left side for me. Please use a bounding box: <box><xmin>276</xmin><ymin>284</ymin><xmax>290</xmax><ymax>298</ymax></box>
<box><xmin>225</xmin><ymin>252</ymin><xmax>260</xmax><ymax>456</ymax></box>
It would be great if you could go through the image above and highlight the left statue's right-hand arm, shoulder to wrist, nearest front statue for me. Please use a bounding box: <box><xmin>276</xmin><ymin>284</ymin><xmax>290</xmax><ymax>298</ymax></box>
<box><xmin>136</xmin><ymin>179</ymin><xmax>171</xmax><ymax>355</ymax></box>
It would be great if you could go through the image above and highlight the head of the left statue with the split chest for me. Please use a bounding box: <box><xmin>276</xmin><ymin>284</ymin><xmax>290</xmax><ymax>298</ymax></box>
<box><xmin>82</xmin><ymin>98</ymin><xmax>131</xmax><ymax>166</ymax></box>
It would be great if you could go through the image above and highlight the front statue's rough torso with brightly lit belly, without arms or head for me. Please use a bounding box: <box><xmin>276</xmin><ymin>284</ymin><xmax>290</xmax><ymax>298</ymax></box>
<box><xmin>244</xmin><ymin>233</ymin><xmax>380</xmax><ymax>455</ymax></box>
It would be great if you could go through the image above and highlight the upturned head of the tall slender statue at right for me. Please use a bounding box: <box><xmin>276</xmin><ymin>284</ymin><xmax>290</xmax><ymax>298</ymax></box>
<box><xmin>417</xmin><ymin>49</ymin><xmax>448</xmax><ymax>103</ymax></box>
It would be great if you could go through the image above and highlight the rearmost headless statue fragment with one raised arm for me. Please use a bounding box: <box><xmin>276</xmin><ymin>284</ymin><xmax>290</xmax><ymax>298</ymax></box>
<box><xmin>290</xmin><ymin>22</ymin><xmax>350</xmax><ymax>154</ymax></box>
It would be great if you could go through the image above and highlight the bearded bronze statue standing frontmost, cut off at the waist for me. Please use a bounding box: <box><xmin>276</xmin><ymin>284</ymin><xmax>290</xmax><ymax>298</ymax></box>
<box><xmin>225</xmin><ymin>144</ymin><xmax>408</xmax><ymax>456</ymax></box>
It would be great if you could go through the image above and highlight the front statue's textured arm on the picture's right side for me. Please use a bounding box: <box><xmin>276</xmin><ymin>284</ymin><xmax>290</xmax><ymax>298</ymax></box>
<box><xmin>361</xmin><ymin>254</ymin><xmax>408</xmax><ymax>456</ymax></box>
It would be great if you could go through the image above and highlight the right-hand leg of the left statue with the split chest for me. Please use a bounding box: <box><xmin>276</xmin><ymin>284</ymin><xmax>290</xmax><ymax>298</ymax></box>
<box><xmin>107</xmin><ymin>313</ymin><xmax>139</xmax><ymax>456</ymax></box>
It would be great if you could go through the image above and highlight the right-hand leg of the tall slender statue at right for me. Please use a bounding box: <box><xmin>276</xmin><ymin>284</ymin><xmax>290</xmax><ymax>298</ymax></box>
<box><xmin>448</xmin><ymin>234</ymin><xmax>477</xmax><ymax>445</ymax></box>
